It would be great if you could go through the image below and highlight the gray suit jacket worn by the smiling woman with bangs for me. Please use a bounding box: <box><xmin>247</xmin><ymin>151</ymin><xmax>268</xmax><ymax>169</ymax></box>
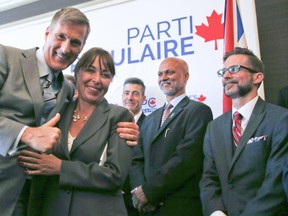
<box><xmin>29</xmin><ymin>99</ymin><xmax>133</xmax><ymax>216</ymax></box>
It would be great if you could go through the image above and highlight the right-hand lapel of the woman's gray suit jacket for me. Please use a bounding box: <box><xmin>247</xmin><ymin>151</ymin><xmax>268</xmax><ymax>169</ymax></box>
<box><xmin>70</xmin><ymin>99</ymin><xmax>110</xmax><ymax>154</ymax></box>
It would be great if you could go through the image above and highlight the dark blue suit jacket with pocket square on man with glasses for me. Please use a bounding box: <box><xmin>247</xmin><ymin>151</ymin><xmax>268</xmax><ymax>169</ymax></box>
<box><xmin>200</xmin><ymin>98</ymin><xmax>288</xmax><ymax>216</ymax></box>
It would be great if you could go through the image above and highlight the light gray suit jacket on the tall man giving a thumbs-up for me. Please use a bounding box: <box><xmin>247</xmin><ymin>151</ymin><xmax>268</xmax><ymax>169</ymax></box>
<box><xmin>0</xmin><ymin>45</ymin><xmax>72</xmax><ymax>216</ymax></box>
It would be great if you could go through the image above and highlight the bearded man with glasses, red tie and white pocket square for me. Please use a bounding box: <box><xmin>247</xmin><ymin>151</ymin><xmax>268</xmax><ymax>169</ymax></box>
<box><xmin>200</xmin><ymin>48</ymin><xmax>288</xmax><ymax>216</ymax></box>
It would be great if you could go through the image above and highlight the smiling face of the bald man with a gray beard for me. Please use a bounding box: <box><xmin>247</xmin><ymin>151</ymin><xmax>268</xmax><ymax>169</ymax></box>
<box><xmin>158</xmin><ymin>58</ymin><xmax>189</xmax><ymax>100</ymax></box>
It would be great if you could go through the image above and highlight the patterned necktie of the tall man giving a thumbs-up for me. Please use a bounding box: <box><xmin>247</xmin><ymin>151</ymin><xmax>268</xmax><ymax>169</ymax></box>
<box><xmin>40</xmin><ymin>73</ymin><xmax>59</xmax><ymax>124</ymax></box>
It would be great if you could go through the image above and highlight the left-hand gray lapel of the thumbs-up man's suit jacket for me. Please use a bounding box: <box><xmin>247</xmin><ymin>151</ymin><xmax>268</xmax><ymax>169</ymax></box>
<box><xmin>20</xmin><ymin>48</ymin><xmax>44</xmax><ymax>125</ymax></box>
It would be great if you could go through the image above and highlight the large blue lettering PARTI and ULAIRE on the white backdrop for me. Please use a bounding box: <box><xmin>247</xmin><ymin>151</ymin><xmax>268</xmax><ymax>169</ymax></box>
<box><xmin>111</xmin><ymin>16</ymin><xmax>194</xmax><ymax>66</ymax></box>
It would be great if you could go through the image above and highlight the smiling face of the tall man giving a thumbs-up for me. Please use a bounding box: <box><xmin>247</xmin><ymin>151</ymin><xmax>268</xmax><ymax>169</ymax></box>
<box><xmin>43</xmin><ymin>22</ymin><xmax>88</xmax><ymax>70</ymax></box>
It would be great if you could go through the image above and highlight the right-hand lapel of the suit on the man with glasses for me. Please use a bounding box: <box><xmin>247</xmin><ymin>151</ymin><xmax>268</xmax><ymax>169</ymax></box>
<box><xmin>230</xmin><ymin>98</ymin><xmax>265</xmax><ymax>170</ymax></box>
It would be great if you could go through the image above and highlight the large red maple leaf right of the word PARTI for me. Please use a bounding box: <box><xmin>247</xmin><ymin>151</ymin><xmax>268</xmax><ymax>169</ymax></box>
<box><xmin>195</xmin><ymin>10</ymin><xmax>224</xmax><ymax>50</ymax></box>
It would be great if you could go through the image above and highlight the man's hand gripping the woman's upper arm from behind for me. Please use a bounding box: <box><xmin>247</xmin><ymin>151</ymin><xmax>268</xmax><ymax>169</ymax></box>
<box><xmin>117</xmin><ymin>122</ymin><xmax>139</xmax><ymax>146</ymax></box>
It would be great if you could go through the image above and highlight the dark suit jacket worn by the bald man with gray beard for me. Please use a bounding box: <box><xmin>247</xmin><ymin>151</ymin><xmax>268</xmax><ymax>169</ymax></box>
<box><xmin>130</xmin><ymin>97</ymin><xmax>212</xmax><ymax>215</ymax></box>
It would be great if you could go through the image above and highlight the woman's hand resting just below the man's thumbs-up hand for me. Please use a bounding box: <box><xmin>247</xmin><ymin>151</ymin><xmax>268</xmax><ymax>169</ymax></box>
<box><xmin>18</xmin><ymin>150</ymin><xmax>62</xmax><ymax>175</ymax></box>
